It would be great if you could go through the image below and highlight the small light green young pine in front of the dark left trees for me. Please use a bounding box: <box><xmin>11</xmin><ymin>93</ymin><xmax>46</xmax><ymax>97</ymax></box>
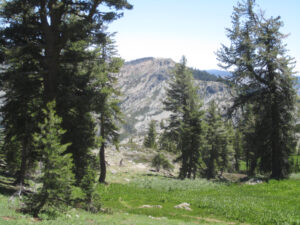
<box><xmin>26</xmin><ymin>102</ymin><xmax>75</xmax><ymax>217</ymax></box>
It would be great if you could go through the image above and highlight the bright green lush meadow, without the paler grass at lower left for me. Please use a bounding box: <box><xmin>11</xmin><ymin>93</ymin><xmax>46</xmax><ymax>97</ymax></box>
<box><xmin>99</xmin><ymin>177</ymin><xmax>300</xmax><ymax>224</ymax></box>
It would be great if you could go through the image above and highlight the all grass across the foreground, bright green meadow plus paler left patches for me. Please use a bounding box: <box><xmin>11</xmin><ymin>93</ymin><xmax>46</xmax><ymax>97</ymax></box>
<box><xmin>0</xmin><ymin>170</ymin><xmax>300</xmax><ymax>225</ymax></box>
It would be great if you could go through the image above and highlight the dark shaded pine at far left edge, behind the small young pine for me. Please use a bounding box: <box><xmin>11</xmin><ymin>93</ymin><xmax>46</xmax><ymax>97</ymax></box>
<box><xmin>0</xmin><ymin>22</ymin><xmax>42</xmax><ymax>184</ymax></box>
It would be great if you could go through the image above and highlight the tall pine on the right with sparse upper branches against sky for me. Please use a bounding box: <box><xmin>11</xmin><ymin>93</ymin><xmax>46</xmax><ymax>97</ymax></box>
<box><xmin>218</xmin><ymin>0</ymin><xmax>295</xmax><ymax>179</ymax></box>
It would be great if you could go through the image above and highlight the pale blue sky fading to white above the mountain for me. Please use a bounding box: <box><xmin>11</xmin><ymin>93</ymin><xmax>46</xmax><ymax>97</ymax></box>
<box><xmin>109</xmin><ymin>0</ymin><xmax>300</xmax><ymax>72</ymax></box>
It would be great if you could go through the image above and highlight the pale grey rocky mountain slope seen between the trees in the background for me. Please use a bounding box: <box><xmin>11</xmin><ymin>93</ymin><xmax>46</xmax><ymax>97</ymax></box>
<box><xmin>118</xmin><ymin>58</ymin><xmax>230</xmax><ymax>142</ymax></box>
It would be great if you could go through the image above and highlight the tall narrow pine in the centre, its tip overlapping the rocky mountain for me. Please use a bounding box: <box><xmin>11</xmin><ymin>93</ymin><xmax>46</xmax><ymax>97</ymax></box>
<box><xmin>163</xmin><ymin>57</ymin><xmax>204</xmax><ymax>179</ymax></box>
